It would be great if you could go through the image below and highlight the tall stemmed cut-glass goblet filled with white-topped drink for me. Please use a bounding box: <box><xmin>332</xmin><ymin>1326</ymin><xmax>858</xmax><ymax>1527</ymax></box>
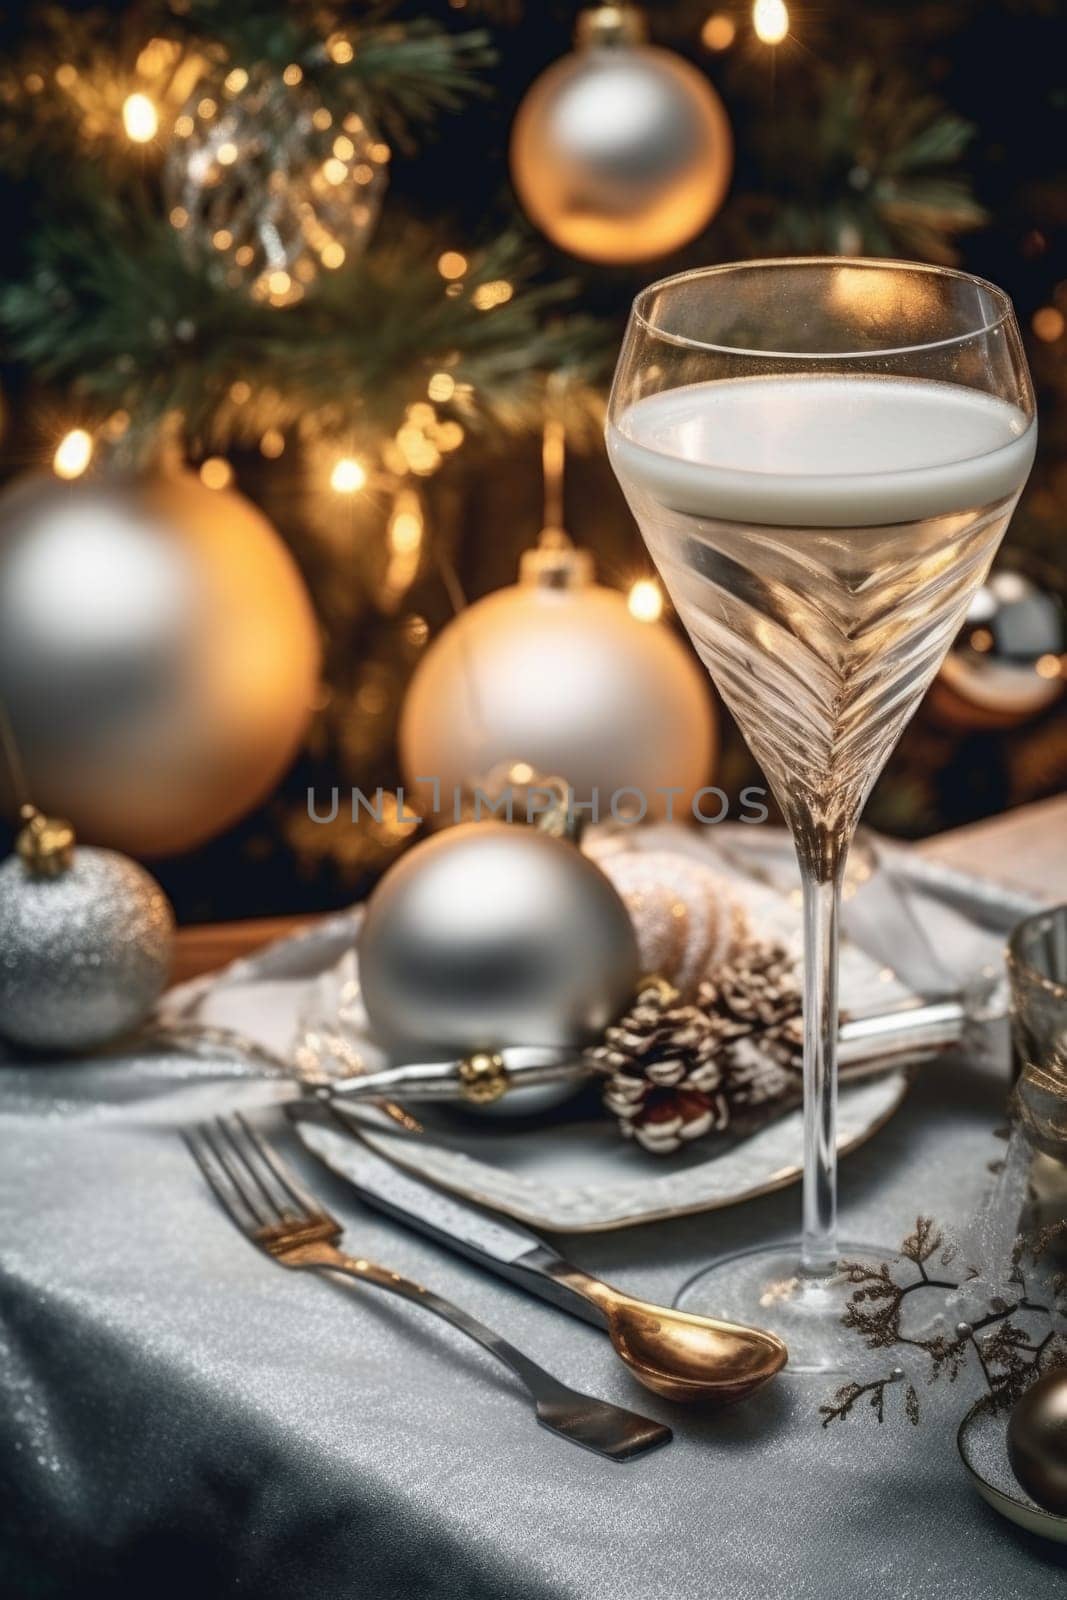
<box><xmin>608</xmin><ymin>258</ymin><xmax>1037</xmax><ymax>1371</ymax></box>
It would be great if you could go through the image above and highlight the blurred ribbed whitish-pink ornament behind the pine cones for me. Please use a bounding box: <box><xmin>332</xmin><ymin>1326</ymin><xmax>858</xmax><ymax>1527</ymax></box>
<box><xmin>593</xmin><ymin>850</ymin><xmax>745</xmax><ymax>995</ymax></box>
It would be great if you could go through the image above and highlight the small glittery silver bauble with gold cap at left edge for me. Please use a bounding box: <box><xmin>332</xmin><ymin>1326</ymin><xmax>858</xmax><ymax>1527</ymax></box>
<box><xmin>0</xmin><ymin>846</ymin><xmax>174</xmax><ymax>1053</ymax></box>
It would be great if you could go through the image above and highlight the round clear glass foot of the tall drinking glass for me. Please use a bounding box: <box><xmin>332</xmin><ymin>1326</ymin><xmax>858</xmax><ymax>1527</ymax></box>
<box><xmin>675</xmin><ymin>1242</ymin><xmax>897</xmax><ymax>1376</ymax></box>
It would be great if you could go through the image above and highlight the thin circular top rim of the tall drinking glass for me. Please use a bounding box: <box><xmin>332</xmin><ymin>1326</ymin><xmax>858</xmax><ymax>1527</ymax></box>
<box><xmin>630</xmin><ymin>256</ymin><xmax>1014</xmax><ymax>362</ymax></box>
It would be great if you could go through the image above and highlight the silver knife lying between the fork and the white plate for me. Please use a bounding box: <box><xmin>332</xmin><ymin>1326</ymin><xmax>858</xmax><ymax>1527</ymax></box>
<box><xmin>286</xmin><ymin>1101</ymin><xmax>627</xmax><ymax>1328</ymax></box>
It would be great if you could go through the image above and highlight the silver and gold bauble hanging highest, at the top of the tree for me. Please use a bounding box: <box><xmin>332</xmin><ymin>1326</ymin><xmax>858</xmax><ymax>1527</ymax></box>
<box><xmin>510</xmin><ymin>6</ymin><xmax>733</xmax><ymax>262</ymax></box>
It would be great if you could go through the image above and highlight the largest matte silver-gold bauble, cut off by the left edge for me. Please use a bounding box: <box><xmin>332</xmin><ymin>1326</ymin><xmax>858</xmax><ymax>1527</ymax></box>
<box><xmin>0</xmin><ymin>472</ymin><xmax>318</xmax><ymax>856</ymax></box>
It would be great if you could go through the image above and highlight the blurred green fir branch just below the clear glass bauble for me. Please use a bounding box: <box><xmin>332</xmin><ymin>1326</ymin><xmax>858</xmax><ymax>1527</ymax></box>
<box><xmin>0</xmin><ymin>195</ymin><xmax>603</xmax><ymax>456</ymax></box>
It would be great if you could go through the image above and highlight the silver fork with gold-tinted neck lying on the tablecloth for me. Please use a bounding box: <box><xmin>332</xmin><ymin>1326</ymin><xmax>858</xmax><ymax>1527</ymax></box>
<box><xmin>184</xmin><ymin>1112</ymin><xmax>672</xmax><ymax>1461</ymax></box>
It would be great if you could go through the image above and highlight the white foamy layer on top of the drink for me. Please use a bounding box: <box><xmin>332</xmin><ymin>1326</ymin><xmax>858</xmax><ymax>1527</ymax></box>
<box><xmin>608</xmin><ymin>374</ymin><xmax>1037</xmax><ymax>528</ymax></box>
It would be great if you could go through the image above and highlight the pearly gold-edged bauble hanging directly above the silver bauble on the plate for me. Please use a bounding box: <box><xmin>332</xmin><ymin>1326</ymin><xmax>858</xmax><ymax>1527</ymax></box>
<box><xmin>400</xmin><ymin>550</ymin><xmax>715</xmax><ymax>821</ymax></box>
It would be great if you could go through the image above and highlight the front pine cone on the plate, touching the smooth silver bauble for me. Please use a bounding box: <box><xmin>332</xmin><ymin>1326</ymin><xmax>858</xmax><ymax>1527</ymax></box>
<box><xmin>587</xmin><ymin>981</ymin><xmax>733</xmax><ymax>1154</ymax></box>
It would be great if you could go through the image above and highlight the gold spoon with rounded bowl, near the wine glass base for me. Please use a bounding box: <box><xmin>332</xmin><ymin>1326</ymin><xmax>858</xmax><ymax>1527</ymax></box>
<box><xmin>537</xmin><ymin>1251</ymin><xmax>789</xmax><ymax>1405</ymax></box>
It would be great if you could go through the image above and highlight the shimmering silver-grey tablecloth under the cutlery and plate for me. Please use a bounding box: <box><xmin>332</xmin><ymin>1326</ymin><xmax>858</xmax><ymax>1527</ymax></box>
<box><xmin>0</xmin><ymin>844</ymin><xmax>1067</xmax><ymax>1600</ymax></box>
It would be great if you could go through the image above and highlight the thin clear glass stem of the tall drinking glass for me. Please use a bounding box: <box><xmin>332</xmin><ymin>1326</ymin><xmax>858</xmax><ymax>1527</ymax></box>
<box><xmin>800</xmin><ymin>856</ymin><xmax>843</xmax><ymax>1275</ymax></box>
